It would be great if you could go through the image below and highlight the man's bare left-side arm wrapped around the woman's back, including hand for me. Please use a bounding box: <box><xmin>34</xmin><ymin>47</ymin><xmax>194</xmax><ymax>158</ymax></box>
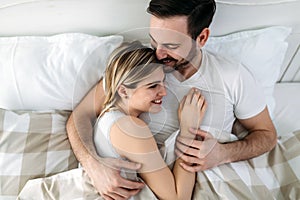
<box><xmin>67</xmin><ymin>81</ymin><xmax>144</xmax><ymax>199</ymax></box>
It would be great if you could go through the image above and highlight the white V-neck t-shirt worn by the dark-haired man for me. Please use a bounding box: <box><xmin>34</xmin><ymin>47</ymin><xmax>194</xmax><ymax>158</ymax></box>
<box><xmin>140</xmin><ymin>50</ymin><xmax>266</xmax><ymax>146</ymax></box>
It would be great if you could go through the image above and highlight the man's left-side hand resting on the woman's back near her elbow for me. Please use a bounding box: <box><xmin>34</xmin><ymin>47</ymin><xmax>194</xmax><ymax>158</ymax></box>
<box><xmin>85</xmin><ymin>158</ymin><xmax>144</xmax><ymax>200</ymax></box>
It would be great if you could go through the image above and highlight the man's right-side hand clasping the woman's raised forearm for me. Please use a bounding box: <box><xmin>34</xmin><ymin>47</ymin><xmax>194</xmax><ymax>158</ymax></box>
<box><xmin>175</xmin><ymin>129</ymin><xmax>226</xmax><ymax>172</ymax></box>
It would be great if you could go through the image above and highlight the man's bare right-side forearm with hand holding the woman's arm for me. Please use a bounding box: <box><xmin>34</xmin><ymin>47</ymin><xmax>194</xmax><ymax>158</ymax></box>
<box><xmin>177</xmin><ymin>108</ymin><xmax>277</xmax><ymax>172</ymax></box>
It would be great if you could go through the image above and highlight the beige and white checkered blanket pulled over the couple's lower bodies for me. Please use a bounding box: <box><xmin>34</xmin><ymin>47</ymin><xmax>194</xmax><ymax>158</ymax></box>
<box><xmin>19</xmin><ymin>131</ymin><xmax>300</xmax><ymax>200</ymax></box>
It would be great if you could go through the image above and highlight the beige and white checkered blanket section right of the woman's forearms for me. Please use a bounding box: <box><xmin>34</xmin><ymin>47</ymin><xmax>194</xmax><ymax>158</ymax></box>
<box><xmin>194</xmin><ymin>131</ymin><xmax>300</xmax><ymax>200</ymax></box>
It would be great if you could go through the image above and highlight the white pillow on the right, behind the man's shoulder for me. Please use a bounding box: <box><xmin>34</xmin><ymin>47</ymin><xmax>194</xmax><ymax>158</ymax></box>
<box><xmin>205</xmin><ymin>26</ymin><xmax>291</xmax><ymax>118</ymax></box>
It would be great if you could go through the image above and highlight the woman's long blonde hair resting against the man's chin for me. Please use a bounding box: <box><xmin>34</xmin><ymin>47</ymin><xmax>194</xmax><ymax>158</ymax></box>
<box><xmin>100</xmin><ymin>41</ymin><xmax>162</xmax><ymax>115</ymax></box>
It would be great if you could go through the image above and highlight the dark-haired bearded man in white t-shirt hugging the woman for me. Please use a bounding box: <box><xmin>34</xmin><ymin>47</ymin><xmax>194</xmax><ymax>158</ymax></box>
<box><xmin>67</xmin><ymin>0</ymin><xmax>276</xmax><ymax>199</ymax></box>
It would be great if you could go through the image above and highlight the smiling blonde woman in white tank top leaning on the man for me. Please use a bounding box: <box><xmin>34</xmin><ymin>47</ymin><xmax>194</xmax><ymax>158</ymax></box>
<box><xmin>94</xmin><ymin>42</ymin><xmax>206</xmax><ymax>200</ymax></box>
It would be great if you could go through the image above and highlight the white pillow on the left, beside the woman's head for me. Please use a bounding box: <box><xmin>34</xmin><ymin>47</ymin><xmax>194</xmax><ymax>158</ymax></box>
<box><xmin>0</xmin><ymin>33</ymin><xmax>123</xmax><ymax>110</ymax></box>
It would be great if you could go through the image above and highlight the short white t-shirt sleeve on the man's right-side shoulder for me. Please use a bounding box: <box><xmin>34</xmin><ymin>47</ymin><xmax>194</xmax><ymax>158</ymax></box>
<box><xmin>234</xmin><ymin>66</ymin><xmax>266</xmax><ymax>119</ymax></box>
